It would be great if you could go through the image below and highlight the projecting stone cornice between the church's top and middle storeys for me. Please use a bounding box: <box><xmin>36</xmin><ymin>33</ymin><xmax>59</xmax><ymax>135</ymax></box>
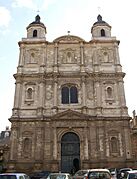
<box><xmin>14</xmin><ymin>72</ymin><xmax>125</xmax><ymax>83</ymax></box>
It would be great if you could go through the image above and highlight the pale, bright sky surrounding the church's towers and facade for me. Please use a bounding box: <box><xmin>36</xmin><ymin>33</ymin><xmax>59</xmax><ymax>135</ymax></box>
<box><xmin>0</xmin><ymin>0</ymin><xmax>137</xmax><ymax>131</ymax></box>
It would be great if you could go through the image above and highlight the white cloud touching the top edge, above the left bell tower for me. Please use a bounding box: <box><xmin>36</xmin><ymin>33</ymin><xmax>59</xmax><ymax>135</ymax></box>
<box><xmin>12</xmin><ymin>0</ymin><xmax>37</xmax><ymax>10</ymax></box>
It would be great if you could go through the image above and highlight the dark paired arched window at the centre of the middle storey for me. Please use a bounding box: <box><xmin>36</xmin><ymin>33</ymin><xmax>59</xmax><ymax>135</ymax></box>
<box><xmin>61</xmin><ymin>85</ymin><xmax>78</xmax><ymax>104</ymax></box>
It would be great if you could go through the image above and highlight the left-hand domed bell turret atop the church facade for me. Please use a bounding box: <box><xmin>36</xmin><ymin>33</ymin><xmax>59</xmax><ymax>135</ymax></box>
<box><xmin>27</xmin><ymin>15</ymin><xmax>47</xmax><ymax>38</ymax></box>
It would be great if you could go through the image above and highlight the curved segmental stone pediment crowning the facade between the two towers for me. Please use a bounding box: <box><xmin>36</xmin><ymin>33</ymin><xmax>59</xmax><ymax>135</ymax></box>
<box><xmin>53</xmin><ymin>35</ymin><xmax>85</xmax><ymax>43</ymax></box>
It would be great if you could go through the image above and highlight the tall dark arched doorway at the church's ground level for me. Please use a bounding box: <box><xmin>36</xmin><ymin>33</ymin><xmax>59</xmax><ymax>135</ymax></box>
<box><xmin>61</xmin><ymin>132</ymin><xmax>80</xmax><ymax>173</ymax></box>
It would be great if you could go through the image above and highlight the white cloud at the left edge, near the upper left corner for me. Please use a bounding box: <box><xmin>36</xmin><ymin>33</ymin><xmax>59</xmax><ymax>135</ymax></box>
<box><xmin>0</xmin><ymin>6</ymin><xmax>11</xmax><ymax>27</ymax></box>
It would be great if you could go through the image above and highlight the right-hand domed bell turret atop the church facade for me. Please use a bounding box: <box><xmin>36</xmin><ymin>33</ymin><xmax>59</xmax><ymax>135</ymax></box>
<box><xmin>91</xmin><ymin>15</ymin><xmax>111</xmax><ymax>38</ymax></box>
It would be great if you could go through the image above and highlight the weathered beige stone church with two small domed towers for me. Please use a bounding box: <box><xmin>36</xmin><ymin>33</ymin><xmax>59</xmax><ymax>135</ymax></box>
<box><xmin>7</xmin><ymin>15</ymin><xmax>137</xmax><ymax>172</ymax></box>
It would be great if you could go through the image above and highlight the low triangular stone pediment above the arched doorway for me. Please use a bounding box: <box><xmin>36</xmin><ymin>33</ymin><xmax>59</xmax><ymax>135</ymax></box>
<box><xmin>52</xmin><ymin>109</ymin><xmax>90</xmax><ymax>119</ymax></box>
